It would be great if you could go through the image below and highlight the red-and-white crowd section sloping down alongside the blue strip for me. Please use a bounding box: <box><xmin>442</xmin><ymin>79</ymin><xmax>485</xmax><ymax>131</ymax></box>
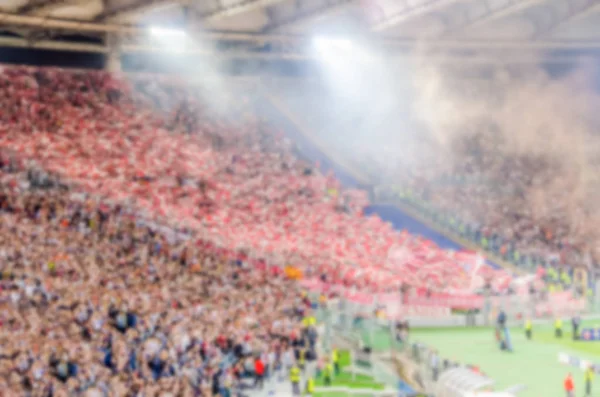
<box><xmin>0</xmin><ymin>68</ymin><xmax>508</xmax><ymax>289</ymax></box>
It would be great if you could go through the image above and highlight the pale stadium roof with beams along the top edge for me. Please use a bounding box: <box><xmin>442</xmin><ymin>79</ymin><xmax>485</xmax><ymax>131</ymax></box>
<box><xmin>0</xmin><ymin>0</ymin><xmax>600</xmax><ymax>60</ymax></box>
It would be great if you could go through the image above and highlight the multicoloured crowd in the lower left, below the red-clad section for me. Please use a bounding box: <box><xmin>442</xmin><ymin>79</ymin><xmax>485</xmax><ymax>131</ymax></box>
<box><xmin>0</xmin><ymin>159</ymin><xmax>322</xmax><ymax>396</ymax></box>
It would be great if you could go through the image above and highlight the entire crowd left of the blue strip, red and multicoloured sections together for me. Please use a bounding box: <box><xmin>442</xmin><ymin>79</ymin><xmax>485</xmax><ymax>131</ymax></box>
<box><xmin>0</xmin><ymin>67</ymin><xmax>516</xmax><ymax>397</ymax></box>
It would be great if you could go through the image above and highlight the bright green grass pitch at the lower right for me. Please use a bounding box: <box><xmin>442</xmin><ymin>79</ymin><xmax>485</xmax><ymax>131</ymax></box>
<box><xmin>365</xmin><ymin>322</ymin><xmax>600</xmax><ymax>397</ymax></box>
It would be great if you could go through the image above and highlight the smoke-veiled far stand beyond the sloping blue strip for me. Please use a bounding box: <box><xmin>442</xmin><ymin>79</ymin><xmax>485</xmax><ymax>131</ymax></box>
<box><xmin>271</xmin><ymin>80</ymin><xmax>597</xmax><ymax>293</ymax></box>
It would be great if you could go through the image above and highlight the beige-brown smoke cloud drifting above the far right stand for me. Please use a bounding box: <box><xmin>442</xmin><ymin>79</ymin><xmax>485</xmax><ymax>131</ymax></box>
<box><xmin>412</xmin><ymin>52</ymin><xmax>600</xmax><ymax>252</ymax></box>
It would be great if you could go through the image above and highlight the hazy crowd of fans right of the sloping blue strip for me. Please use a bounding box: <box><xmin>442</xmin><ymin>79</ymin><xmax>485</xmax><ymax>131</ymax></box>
<box><xmin>273</xmin><ymin>79</ymin><xmax>600</xmax><ymax>283</ymax></box>
